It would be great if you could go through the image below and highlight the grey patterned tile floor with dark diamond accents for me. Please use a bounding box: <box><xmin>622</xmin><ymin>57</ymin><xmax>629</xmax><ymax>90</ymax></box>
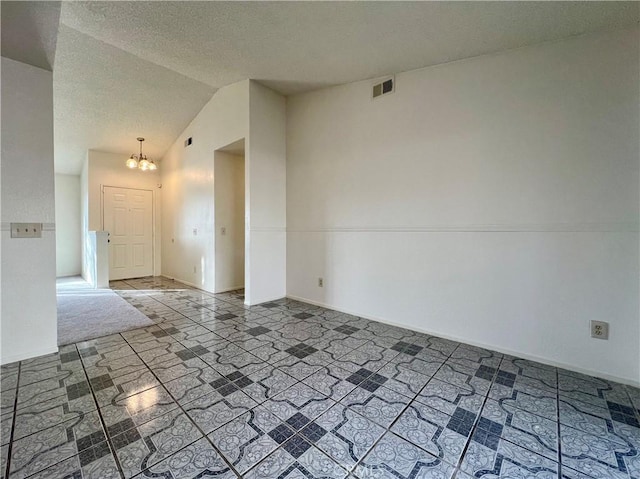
<box><xmin>0</xmin><ymin>278</ymin><xmax>640</xmax><ymax>479</ymax></box>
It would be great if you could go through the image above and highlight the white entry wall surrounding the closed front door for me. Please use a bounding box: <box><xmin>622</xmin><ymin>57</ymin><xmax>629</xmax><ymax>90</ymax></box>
<box><xmin>83</xmin><ymin>150</ymin><xmax>162</xmax><ymax>279</ymax></box>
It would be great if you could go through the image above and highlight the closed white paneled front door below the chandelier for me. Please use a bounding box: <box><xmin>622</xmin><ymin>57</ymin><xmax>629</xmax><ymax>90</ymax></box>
<box><xmin>102</xmin><ymin>186</ymin><xmax>153</xmax><ymax>280</ymax></box>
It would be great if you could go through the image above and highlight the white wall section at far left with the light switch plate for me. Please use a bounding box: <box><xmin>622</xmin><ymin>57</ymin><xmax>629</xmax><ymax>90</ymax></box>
<box><xmin>0</xmin><ymin>57</ymin><xmax>58</xmax><ymax>364</ymax></box>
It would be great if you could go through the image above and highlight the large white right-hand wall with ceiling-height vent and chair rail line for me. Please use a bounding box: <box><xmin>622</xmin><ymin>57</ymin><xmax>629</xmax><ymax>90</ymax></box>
<box><xmin>287</xmin><ymin>29</ymin><xmax>640</xmax><ymax>383</ymax></box>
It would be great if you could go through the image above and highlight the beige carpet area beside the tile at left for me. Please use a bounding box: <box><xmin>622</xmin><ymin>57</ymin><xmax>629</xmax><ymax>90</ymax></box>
<box><xmin>56</xmin><ymin>276</ymin><xmax>154</xmax><ymax>346</ymax></box>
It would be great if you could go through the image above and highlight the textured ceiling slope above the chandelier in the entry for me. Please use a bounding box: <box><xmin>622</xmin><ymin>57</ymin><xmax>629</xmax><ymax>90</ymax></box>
<box><xmin>53</xmin><ymin>25</ymin><xmax>215</xmax><ymax>174</ymax></box>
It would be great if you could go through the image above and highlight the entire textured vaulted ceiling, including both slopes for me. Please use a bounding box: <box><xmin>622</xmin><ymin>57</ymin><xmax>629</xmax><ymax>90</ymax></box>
<box><xmin>2</xmin><ymin>1</ymin><xmax>640</xmax><ymax>174</ymax></box>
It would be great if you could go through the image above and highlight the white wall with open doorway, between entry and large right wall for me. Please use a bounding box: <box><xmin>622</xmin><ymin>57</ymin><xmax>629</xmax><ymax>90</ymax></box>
<box><xmin>161</xmin><ymin>80</ymin><xmax>286</xmax><ymax>304</ymax></box>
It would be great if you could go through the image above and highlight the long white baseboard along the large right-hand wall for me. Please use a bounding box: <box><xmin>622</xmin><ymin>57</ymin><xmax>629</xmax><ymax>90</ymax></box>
<box><xmin>287</xmin><ymin>295</ymin><xmax>640</xmax><ymax>387</ymax></box>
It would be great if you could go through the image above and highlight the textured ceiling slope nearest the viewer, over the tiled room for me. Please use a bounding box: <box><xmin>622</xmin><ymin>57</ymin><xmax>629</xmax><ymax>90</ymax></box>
<box><xmin>61</xmin><ymin>1</ymin><xmax>639</xmax><ymax>95</ymax></box>
